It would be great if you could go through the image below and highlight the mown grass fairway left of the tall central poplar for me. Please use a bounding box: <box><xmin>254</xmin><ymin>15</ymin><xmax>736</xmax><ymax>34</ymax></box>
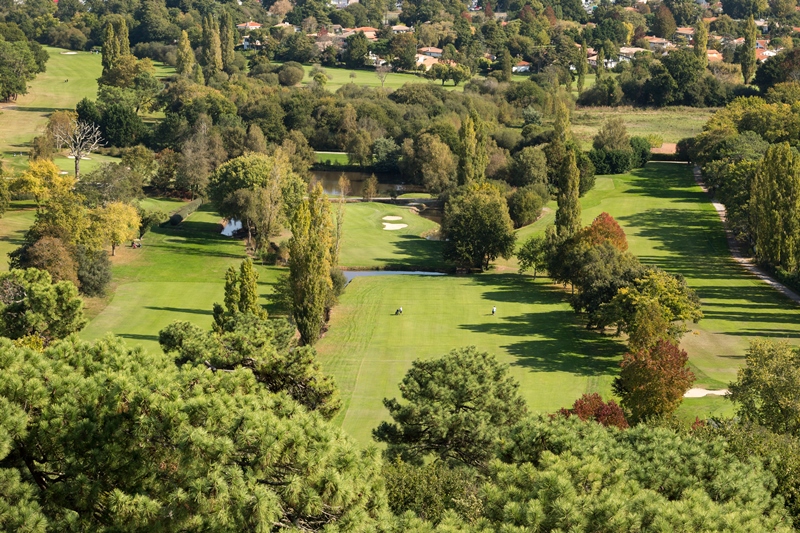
<box><xmin>81</xmin><ymin>206</ymin><xmax>279</xmax><ymax>352</ymax></box>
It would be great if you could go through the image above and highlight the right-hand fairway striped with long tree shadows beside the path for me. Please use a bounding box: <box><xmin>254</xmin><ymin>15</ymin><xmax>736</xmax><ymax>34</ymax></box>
<box><xmin>509</xmin><ymin>163</ymin><xmax>800</xmax><ymax>388</ymax></box>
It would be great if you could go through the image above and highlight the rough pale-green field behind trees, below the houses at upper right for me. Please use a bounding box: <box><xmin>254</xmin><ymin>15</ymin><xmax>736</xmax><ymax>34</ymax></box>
<box><xmin>572</xmin><ymin>106</ymin><xmax>714</xmax><ymax>150</ymax></box>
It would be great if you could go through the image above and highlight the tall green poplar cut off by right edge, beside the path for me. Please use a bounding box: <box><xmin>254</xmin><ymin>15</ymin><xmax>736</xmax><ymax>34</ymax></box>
<box><xmin>750</xmin><ymin>142</ymin><xmax>800</xmax><ymax>272</ymax></box>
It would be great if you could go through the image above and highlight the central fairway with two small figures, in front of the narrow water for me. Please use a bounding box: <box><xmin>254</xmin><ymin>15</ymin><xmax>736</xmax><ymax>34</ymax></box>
<box><xmin>317</xmin><ymin>273</ymin><xmax>623</xmax><ymax>444</ymax></box>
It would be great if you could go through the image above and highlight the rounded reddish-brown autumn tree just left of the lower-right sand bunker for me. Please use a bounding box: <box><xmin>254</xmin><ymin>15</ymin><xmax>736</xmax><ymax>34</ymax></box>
<box><xmin>613</xmin><ymin>340</ymin><xmax>694</xmax><ymax>423</ymax></box>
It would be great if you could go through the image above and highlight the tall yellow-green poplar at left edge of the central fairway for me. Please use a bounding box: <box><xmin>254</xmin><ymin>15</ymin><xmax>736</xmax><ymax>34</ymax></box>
<box><xmin>289</xmin><ymin>183</ymin><xmax>332</xmax><ymax>345</ymax></box>
